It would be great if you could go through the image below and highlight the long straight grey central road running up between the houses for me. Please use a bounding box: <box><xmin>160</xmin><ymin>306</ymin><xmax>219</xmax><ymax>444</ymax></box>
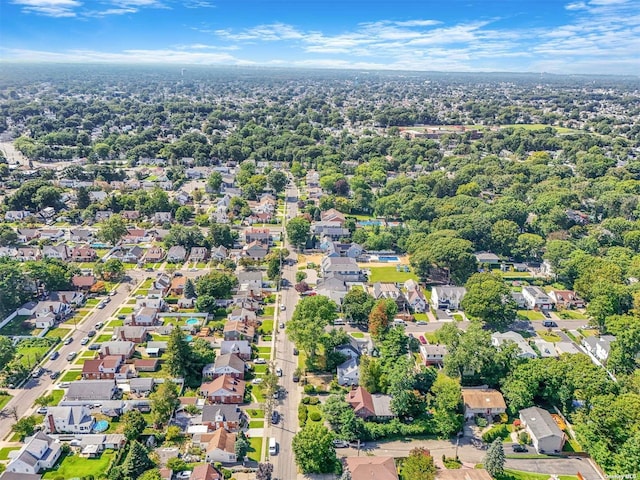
<box><xmin>266</xmin><ymin>183</ymin><xmax>301</xmax><ymax>479</ymax></box>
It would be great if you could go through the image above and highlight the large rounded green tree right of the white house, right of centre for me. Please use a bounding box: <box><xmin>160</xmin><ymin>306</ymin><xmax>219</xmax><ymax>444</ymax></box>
<box><xmin>462</xmin><ymin>273</ymin><xmax>516</xmax><ymax>328</ymax></box>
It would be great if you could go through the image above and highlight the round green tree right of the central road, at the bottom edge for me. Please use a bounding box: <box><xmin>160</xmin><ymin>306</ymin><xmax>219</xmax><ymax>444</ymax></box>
<box><xmin>291</xmin><ymin>422</ymin><xmax>337</xmax><ymax>474</ymax></box>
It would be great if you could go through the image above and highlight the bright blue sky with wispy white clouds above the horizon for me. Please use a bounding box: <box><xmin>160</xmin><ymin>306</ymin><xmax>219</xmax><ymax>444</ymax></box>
<box><xmin>0</xmin><ymin>0</ymin><xmax>640</xmax><ymax>75</ymax></box>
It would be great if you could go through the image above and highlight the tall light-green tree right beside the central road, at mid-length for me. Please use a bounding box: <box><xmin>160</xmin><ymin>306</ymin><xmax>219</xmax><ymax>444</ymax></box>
<box><xmin>287</xmin><ymin>295</ymin><xmax>337</xmax><ymax>362</ymax></box>
